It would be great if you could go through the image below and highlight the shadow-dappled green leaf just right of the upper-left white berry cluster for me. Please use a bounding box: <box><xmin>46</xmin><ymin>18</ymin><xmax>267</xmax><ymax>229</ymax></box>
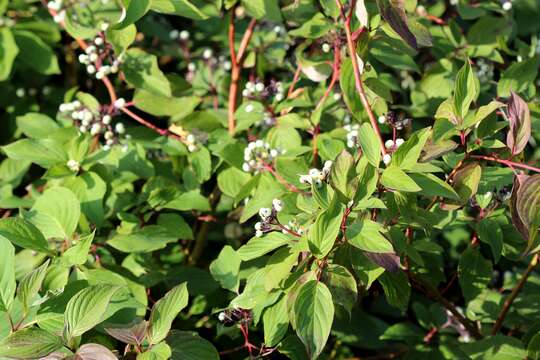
<box><xmin>122</xmin><ymin>48</ymin><xmax>172</xmax><ymax>97</ymax></box>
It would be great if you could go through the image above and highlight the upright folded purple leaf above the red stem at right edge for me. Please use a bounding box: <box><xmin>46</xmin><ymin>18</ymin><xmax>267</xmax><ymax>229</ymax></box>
<box><xmin>506</xmin><ymin>92</ymin><xmax>531</xmax><ymax>155</ymax></box>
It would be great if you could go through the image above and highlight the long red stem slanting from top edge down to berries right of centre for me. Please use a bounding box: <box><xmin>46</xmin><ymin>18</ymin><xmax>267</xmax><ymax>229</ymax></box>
<box><xmin>336</xmin><ymin>0</ymin><xmax>386</xmax><ymax>155</ymax></box>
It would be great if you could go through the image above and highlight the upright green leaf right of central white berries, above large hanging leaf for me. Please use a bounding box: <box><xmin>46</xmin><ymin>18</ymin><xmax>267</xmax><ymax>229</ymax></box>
<box><xmin>308</xmin><ymin>195</ymin><xmax>344</xmax><ymax>258</ymax></box>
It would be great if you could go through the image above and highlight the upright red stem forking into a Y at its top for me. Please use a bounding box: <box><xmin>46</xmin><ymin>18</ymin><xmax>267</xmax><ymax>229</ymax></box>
<box><xmin>228</xmin><ymin>13</ymin><xmax>257</xmax><ymax>135</ymax></box>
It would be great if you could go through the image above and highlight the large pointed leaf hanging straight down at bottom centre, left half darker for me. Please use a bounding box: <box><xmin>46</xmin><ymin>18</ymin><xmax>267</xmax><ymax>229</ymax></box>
<box><xmin>294</xmin><ymin>280</ymin><xmax>334</xmax><ymax>359</ymax></box>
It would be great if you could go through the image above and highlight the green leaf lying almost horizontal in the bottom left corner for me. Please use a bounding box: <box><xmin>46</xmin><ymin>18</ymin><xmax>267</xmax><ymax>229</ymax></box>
<box><xmin>0</xmin><ymin>327</ymin><xmax>62</xmax><ymax>359</ymax></box>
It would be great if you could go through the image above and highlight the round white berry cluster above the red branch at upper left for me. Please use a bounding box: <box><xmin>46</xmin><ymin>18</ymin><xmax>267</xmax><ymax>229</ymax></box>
<box><xmin>79</xmin><ymin>33</ymin><xmax>123</xmax><ymax>80</ymax></box>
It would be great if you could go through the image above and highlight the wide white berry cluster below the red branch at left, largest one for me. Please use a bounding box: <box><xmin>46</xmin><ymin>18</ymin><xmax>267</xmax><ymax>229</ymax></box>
<box><xmin>59</xmin><ymin>98</ymin><xmax>130</xmax><ymax>150</ymax></box>
